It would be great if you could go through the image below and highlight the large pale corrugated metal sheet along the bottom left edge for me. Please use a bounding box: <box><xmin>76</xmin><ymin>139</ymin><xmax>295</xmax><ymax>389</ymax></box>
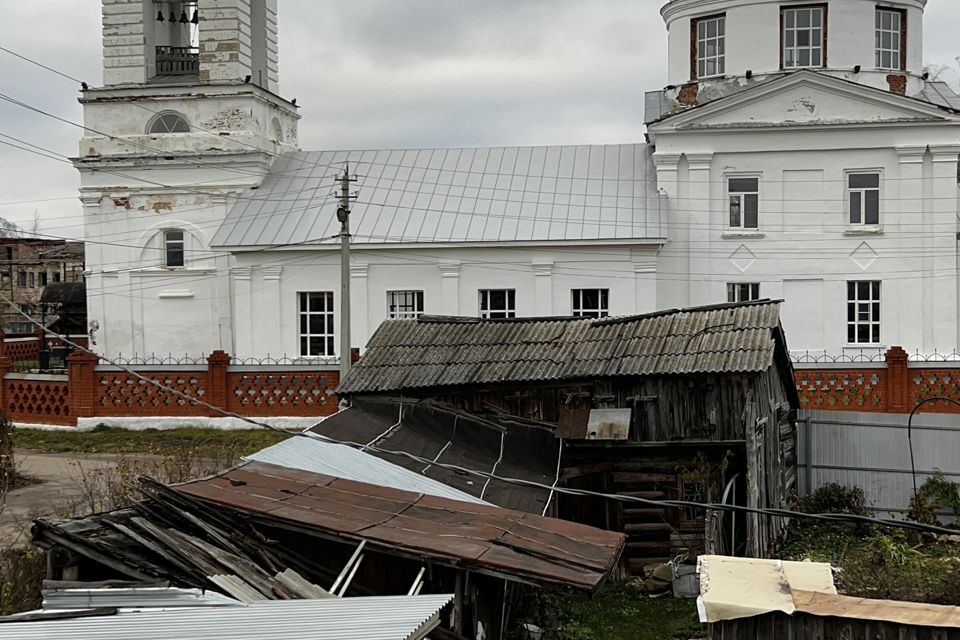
<box><xmin>0</xmin><ymin>595</ymin><xmax>453</xmax><ymax>640</ymax></box>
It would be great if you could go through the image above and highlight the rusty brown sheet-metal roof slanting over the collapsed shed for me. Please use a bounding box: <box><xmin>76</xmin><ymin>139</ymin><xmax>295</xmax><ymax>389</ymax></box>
<box><xmin>171</xmin><ymin>462</ymin><xmax>624</xmax><ymax>591</ymax></box>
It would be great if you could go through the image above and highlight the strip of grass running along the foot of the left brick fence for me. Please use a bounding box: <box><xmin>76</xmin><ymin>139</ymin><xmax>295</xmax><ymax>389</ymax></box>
<box><xmin>11</xmin><ymin>427</ymin><xmax>289</xmax><ymax>458</ymax></box>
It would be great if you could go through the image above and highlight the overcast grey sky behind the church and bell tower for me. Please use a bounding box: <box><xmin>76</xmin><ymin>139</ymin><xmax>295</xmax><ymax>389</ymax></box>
<box><xmin>0</xmin><ymin>0</ymin><xmax>960</xmax><ymax>237</ymax></box>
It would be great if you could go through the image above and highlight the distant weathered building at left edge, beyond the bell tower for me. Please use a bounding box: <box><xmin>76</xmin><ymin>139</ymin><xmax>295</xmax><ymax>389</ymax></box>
<box><xmin>0</xmin><ymin>238</ymin><xmax>84</xmax><ymax>335</ymax></box>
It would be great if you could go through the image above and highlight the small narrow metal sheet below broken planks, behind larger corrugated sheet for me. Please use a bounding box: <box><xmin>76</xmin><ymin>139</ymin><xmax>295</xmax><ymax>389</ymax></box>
<box><xmin>43</xmin><ymin>587</ymin><xmax>243</xmax><ymax>611</ymax></box>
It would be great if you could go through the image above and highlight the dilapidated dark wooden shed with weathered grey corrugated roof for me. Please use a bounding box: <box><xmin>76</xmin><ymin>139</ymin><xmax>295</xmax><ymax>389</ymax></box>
<box><xmin>337</xmin><ymin>301</ymin><xmax>799</xmax><ymax>569</ymax></box>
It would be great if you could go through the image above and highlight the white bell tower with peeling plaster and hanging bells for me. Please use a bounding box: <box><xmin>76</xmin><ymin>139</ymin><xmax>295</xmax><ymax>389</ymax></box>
<box><xmin>74</xmin><ymin>0</ymin><xmax>299</xmax><ymax>355</ymax></box>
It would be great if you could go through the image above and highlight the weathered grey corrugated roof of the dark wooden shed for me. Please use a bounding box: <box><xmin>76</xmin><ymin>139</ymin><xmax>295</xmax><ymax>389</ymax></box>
<box><xmin>337</xmin><ymin>301</ymin><xmax>780</xmax><ymax>395</ymax></box>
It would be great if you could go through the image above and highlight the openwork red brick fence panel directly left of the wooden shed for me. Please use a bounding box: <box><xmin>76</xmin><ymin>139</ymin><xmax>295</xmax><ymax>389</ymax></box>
<box><xmin>227</xmin><ymin>372</ymin><xmax>339</xmax><ymax>416</ymax></box>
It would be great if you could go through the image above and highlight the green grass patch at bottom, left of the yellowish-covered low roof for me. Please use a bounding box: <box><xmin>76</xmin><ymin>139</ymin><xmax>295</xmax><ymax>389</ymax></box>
<box><xmin>538</xmin><ymin>585</ymin><xmax>705</xmax><ymax>640</ymax></box>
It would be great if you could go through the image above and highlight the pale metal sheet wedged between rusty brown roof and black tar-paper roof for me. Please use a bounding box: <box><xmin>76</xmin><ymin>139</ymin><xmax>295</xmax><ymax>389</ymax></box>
<box><xmin>244</xmin><ymin>424</ymin><xmax>489</xmax><ymax>504</ymax></box>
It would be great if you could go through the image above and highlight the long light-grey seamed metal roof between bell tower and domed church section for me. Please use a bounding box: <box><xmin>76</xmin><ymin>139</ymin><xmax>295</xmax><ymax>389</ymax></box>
<box><xmin>211</xmin><ymin>144</ymin><xmax>664</xmax><ymax>249</ymax></box>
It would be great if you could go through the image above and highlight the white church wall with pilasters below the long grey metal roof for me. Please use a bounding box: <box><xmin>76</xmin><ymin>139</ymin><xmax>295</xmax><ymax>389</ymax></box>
<box><xmin>230</xmin><ymin>243</ymin><xmax>660</xmax><ymax>358</ymax></box>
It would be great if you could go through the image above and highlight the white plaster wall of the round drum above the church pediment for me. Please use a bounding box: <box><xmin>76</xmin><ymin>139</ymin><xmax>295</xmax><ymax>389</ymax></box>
<box><xmin>662</xmin><ymin>0</ymin><xmax>925</xmax><ymax>95</ymax></box>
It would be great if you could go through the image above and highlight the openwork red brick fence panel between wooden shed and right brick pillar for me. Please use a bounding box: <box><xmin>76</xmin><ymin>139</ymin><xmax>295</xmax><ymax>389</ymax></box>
<box><xmin>795</xmin><ymin>369</ymin><xmax>886</xmax><ymax>411</ymax></box>
